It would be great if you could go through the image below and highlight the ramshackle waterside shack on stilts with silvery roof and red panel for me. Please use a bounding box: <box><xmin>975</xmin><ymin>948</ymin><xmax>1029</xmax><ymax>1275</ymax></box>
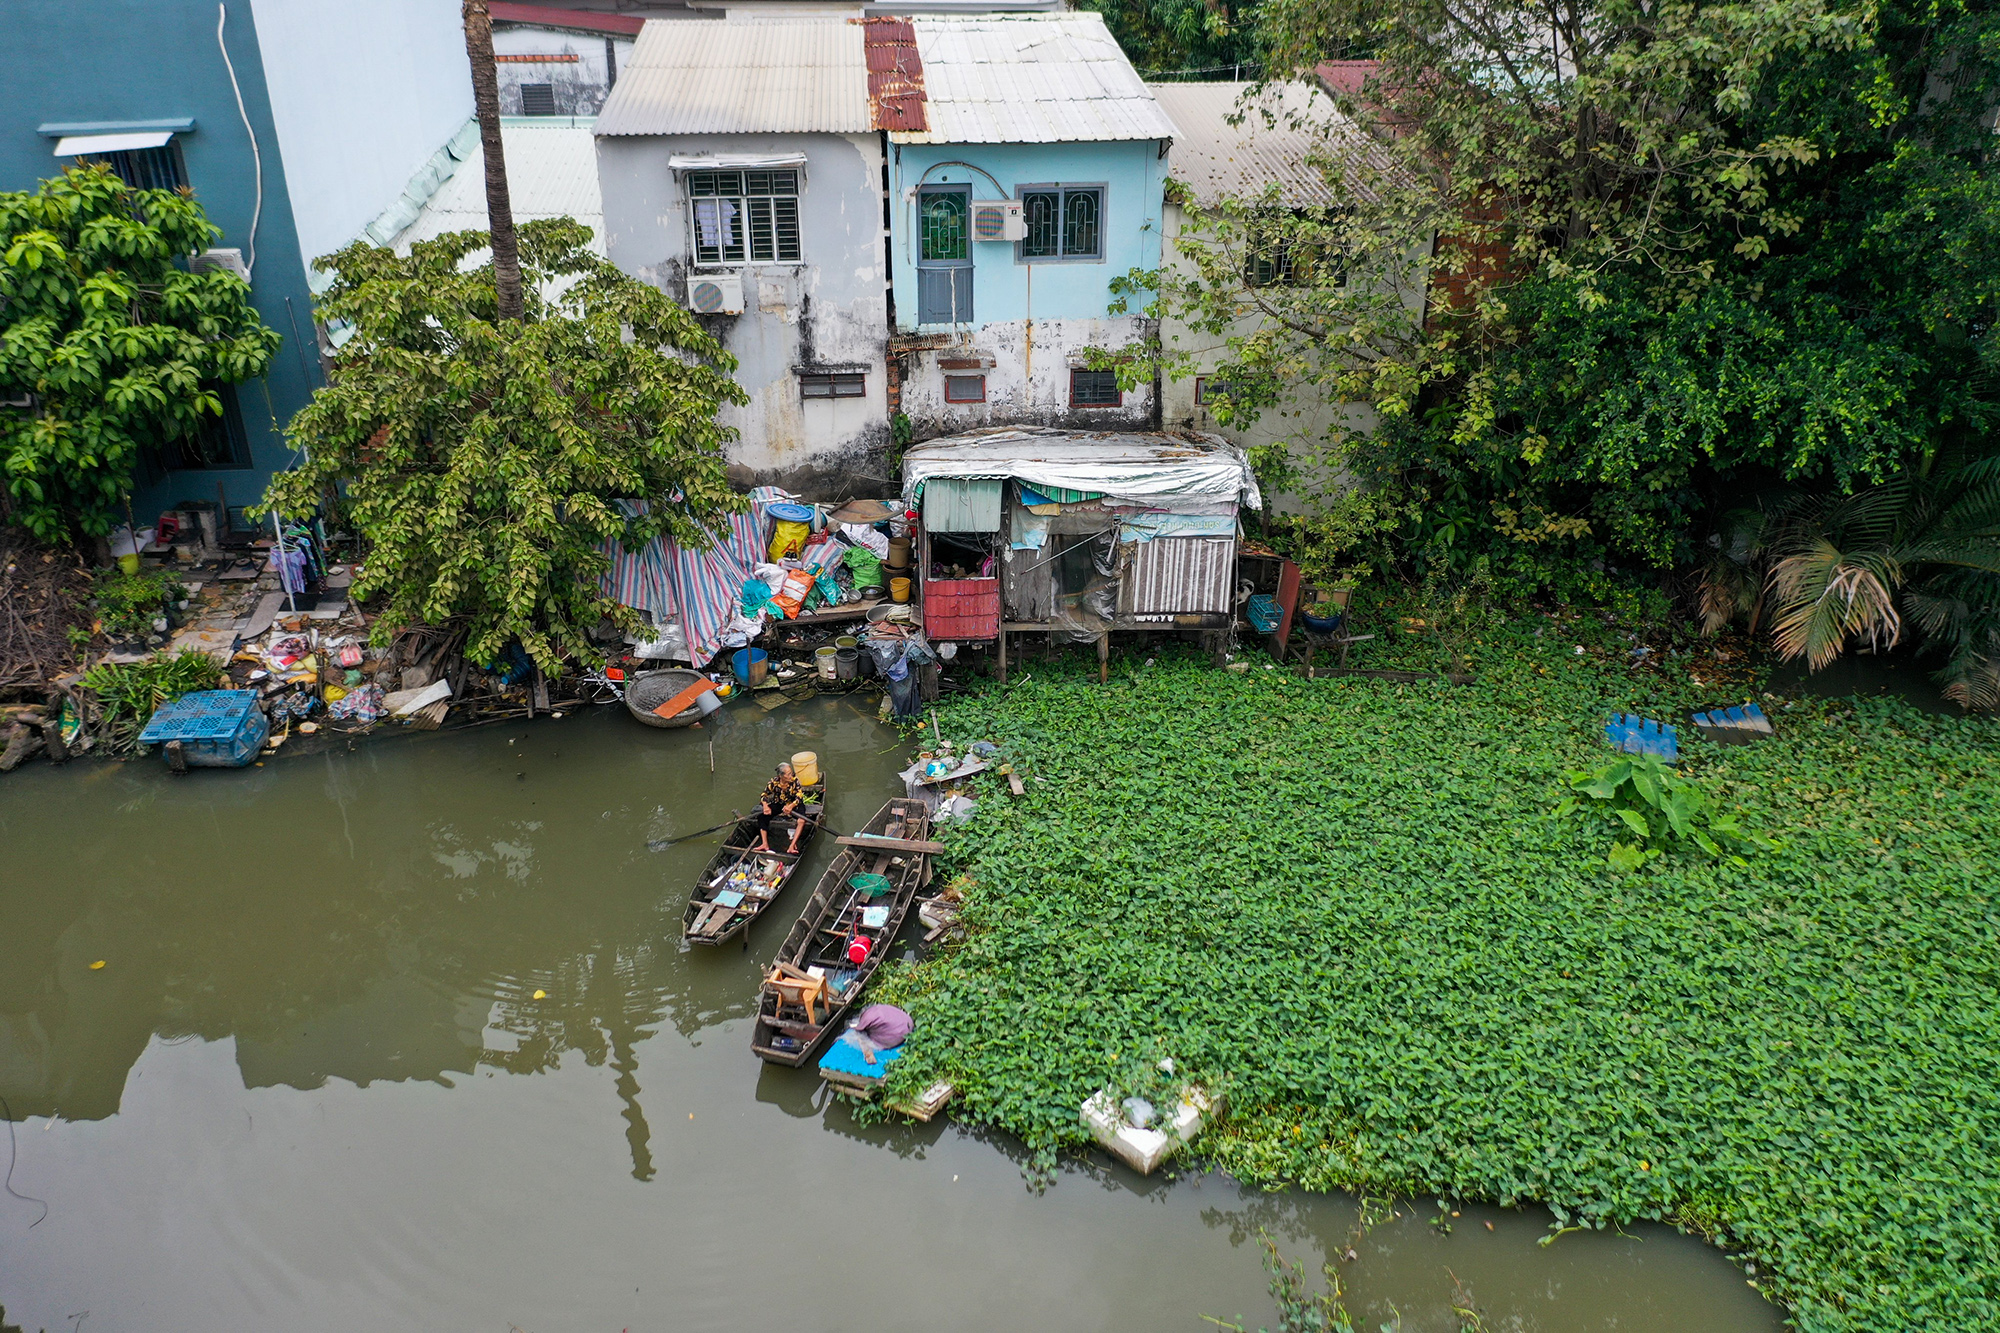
<box><xmin>902</xmin><ymin>426</ymin><xmax>1260</xmax><ymax>681</ymax></box>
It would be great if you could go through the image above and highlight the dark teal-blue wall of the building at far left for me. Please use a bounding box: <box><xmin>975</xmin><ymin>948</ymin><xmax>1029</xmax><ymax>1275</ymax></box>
<box><xmin>0</xmin><ymin>0</ymin><xmax>318</xmax><ymax>524</ymax></box>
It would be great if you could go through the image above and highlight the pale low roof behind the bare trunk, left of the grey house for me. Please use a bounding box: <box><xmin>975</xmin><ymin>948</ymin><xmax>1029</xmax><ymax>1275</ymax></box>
<box><xmin>390</xmin><ymin>116</ymin><xmax>604</xmax><ymax>254</ymax></box>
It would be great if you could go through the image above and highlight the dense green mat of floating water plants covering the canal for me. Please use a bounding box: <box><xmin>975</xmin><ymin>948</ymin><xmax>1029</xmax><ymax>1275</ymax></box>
<box><xmin>884</xmin><ymin>620</ymin><xmax>2000</xmax><ymax>1333</ymax></box>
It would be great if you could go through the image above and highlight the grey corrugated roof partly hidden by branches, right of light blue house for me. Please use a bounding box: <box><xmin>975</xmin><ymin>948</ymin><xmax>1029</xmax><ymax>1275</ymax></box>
<box><xmin>1148</xmin><ymin>84</ymin><xmax>1390</xmax><ymax>208</ymax></box>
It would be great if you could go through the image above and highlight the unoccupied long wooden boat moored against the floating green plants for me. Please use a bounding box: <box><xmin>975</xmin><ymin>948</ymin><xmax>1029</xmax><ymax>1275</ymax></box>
<box><xmin>750</xmin><ymin>801</ymin><xmax>930</xmax><ymax>1069</ymax></box>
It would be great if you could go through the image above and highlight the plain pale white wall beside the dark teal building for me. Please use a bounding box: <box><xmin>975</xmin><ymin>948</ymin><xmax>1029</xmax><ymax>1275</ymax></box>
<box><xmin>246</xmin><ymin>0</ymin><xmax>472</xmax><ymax>264</ymax></box>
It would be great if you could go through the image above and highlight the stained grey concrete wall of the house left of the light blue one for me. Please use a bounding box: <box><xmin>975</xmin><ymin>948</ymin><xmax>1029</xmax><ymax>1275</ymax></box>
<box><xmin>598</xmin><ymin>134</ymin><xmax>890</xmax><ymax>496</ymax></box>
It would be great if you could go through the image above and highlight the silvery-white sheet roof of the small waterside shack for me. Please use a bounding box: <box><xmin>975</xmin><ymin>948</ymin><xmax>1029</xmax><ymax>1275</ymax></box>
<box><xmin>902</xmin><ymin>426</ymin><xmax>1262</xmax><ymax>510</ymax></box>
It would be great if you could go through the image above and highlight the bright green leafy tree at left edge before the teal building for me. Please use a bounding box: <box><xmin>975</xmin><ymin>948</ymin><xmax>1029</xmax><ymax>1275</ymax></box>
<box><xmin>0</xmin><ymin>166</ymin><xmax>278</xmax><ymax>542</ymax></box>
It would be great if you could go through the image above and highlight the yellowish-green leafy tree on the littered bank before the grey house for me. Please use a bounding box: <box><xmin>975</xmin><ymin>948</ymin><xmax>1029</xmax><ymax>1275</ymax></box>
<box><xmin>264</xmin><ymin>218</ymin><xmax>744</xmax><ymax>669</ymax></box>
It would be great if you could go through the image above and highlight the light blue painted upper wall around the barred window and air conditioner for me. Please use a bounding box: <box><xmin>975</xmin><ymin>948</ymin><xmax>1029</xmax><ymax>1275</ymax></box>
<box><xmin>890</xmin><ymin>140</ymin><xmax>1166</xmax><ymax>332</ymax></box>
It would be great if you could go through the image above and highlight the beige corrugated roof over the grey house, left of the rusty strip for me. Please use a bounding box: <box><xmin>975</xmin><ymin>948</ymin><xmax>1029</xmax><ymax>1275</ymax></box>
<box><xmin>598</xmin><ymin>18</ymin><xmax>870</xmax><ymax>134</ymax></box>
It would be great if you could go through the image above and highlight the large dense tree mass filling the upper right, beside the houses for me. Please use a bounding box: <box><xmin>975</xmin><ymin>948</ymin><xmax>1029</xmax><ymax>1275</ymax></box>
<box><xmin>1140</xmin><ymin>0</ymin><xmax>2000</xmax><ymax>616</ymax></box>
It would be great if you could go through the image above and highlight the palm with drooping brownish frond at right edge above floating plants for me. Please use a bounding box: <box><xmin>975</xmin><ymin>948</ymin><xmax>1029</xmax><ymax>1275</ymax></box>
<box><xmin>1764</xmin><ymin>456</ymin><xmax>2000</xmax><ymax>709</ymax></box>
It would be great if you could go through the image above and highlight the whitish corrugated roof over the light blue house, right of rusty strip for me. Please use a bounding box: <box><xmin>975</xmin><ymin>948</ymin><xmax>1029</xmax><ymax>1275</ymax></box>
<box><xmin>890</xmin><ymin>12</ymin><xmax>1176</xmax><ymax>144</ymax></box>
